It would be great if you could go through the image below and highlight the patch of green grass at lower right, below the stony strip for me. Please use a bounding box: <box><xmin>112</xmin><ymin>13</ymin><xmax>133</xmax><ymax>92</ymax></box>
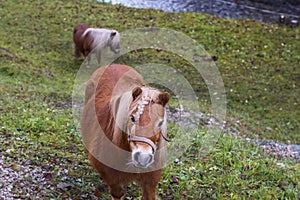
<box><xmin>159</xmin><ymin>135</ymin><xmax>299</xmax><ymax>199</ymax></box>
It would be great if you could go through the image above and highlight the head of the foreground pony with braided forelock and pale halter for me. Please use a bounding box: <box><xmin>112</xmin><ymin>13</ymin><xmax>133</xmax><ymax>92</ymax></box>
<box><xmin>127</xmin><ymin>87</ymin><xmax>170</xmax><ymax>168</ymax></box>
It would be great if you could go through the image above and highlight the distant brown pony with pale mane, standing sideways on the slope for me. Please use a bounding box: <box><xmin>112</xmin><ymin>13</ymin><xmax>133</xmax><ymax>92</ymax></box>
<box><xmin>73</xmin><ymin>24</ymin><xmax>120</xmax><ymax>68</ymax></box>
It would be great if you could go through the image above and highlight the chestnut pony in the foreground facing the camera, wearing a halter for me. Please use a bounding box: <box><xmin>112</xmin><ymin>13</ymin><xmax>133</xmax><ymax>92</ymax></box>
<box><xmin>81</xmin><ymin>64</ymin><xmax>170</xmax><ymax>200</ymax></box>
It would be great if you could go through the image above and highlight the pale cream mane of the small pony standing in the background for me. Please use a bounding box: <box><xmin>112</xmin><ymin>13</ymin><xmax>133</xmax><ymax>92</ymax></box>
<box><xmin>82</xmin><ymin>28</ymin><xmax>120</xmax><ymax>48</ymax></box>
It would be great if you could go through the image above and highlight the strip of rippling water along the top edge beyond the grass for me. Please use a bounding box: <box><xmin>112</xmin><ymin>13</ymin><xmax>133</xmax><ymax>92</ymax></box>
<box><xmin>100</xmin><ymin>0</ymin><xmax>300</xmax><ymax>26</ymax></box>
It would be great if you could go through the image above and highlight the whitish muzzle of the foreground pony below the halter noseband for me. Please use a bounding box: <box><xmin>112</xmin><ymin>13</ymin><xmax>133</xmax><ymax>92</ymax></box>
<box><xmin>131</xmin><ymin>142</ymin><xmax>154</xmax><ymax>168</ymax></box>
